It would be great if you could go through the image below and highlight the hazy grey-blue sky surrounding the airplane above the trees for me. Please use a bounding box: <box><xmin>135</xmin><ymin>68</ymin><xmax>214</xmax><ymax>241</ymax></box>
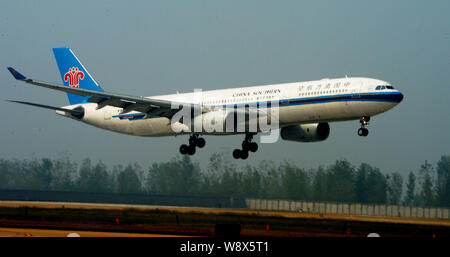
<box><xmin>0</xmin><ymin>1</ymin><xmax>450</xmax><ymax>173</ymax></box>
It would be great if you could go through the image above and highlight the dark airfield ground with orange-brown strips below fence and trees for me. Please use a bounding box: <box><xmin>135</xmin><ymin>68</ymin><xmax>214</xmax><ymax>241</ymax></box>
<box><xmin>0</xmin><ymin>201</ymin><xmax>450</xmax><ymax>237</ymax></box>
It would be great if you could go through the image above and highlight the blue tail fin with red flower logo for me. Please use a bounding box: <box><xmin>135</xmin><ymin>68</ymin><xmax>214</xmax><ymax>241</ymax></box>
<box><xmin>53</xmin><ymin>47</ymin><xmax>103</xmax><ymax>104</ymax></box>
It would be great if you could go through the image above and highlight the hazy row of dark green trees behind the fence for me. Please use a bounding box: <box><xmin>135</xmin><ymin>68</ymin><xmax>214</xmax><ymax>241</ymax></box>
<box><xmin>0</xmin><ymin>153</ymin><xmax>450</xmax><ymax>207</ymax></box>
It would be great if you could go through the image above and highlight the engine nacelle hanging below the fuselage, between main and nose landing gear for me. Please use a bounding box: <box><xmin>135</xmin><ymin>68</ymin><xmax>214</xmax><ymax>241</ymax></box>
<box><xmin>280</xmin><ymin>123</ymin><xmax>330</xmax><ymax>142</ymax></box>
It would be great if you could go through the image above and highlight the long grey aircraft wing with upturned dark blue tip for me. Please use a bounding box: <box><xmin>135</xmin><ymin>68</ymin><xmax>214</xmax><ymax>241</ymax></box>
<box><xmin>8</xmin><ymin>67</ymin><xmax>202</xmax><ymax>118</ymax></box>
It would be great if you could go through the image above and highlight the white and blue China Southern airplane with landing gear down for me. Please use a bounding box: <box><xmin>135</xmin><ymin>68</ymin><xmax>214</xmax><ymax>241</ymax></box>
<box><xmin>7</xmin><ymin>47</ymin><xmax>403</xmax><ymax>159</ymax></box>
